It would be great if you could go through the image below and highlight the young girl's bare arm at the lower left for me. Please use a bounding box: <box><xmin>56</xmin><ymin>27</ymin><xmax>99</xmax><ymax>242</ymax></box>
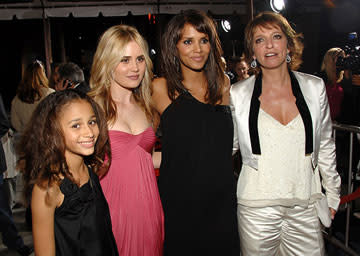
<box><xmin>31</xmin><ymin>185</ymin><xmax>60</xmax><ymax>256</ymax></box>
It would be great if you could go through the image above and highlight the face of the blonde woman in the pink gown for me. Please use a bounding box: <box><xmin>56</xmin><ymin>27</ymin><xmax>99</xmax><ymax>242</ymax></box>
<box><xmin>111</xmin><ymin>41</ymin><xmax>146</xmax><ymax>90</ymax></box>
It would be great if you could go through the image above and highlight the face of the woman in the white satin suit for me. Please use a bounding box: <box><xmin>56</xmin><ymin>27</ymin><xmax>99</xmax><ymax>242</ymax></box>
<box><xmin>253</xmin><ymin>25</ymin><xmax>289</xmax><ymax>69</ymax></box>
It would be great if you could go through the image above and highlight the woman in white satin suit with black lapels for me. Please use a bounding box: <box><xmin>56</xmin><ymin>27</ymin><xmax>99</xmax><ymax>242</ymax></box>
<box><xmin>231</xmin><ymin>12</ymin><xmax>340</xmax><ymax>256</ymax></box>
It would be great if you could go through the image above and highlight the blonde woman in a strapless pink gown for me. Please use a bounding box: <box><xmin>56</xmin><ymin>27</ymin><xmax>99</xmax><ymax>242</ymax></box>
<box><xmin>90</xmin><ymin>25</ymin><xmax>164</xmax><ymax>256</ymax></box>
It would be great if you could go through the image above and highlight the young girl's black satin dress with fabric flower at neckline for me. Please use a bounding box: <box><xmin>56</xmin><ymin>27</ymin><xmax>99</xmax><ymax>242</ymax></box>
<box><xmin>55</xmin><ymin>169</ymin><xmax>118</xmax><ymax>256</ymax></box>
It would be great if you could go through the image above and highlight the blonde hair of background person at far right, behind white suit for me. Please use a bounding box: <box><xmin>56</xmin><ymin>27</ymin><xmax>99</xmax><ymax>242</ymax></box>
<box><xmin>321</xmin><ymin>47</ymin><xmax>345</xmax><ymax>83</ymax></box>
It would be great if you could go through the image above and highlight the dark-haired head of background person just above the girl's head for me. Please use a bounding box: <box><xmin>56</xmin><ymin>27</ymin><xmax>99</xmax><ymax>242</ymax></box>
<box><xmin>55</xmin><ymin>62</ymin><xmax>90</xmax><ymax>93</ymax></box>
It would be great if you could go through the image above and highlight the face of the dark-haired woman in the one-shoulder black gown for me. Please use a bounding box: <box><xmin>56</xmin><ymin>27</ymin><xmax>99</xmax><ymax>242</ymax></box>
<box><xmin>176</xmin><ymin>24</ymin><xmax>211</xmax><ymax>71</ymax></box>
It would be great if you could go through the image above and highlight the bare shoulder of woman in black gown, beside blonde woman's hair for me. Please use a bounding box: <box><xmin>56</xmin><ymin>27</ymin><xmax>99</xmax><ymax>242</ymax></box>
<box><xmin>151</xmin><ymin>77</ymin><xmax>171</xmax><ymax>115</ymax></box>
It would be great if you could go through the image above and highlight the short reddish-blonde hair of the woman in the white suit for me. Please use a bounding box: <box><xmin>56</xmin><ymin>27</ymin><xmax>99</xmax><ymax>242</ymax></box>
<box><xmin>244</xmin><ymin>11</ymin><xmax>304</xmax><ymax>73</ymax></box>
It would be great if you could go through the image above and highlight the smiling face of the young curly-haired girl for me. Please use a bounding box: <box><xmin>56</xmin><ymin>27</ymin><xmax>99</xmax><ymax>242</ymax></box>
<box><xmin>59</xmin><ymin>100</ymin><xmax>99</xmax><ymax>162</ymax></box>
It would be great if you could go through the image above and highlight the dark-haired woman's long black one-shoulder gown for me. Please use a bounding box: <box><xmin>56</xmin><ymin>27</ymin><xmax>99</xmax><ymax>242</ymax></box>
<box><xmin>159</xmin><ymin>92</ymin><xmax>240</xmax><ymax>256</ymax></box>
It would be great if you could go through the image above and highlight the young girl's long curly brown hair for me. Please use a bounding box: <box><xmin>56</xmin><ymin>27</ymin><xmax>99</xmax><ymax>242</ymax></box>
<box><xmin>17</xmin><ymin>89</ymin><xmax>111</xmax><ymax>203</ymax></box>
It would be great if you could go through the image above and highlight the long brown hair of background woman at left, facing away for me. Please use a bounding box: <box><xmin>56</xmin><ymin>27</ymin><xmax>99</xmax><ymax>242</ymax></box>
<box><xmin>17</xmin><ymin>60</ymin><xmax>49</xmax><ymax>104</ymax></box>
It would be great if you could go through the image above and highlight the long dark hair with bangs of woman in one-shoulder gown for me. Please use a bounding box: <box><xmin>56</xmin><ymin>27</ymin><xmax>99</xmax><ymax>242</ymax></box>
<box><xmin>161</xmin><ymin>10</ymin><xmax>225</xmax><ymax>105</ymax></box>
